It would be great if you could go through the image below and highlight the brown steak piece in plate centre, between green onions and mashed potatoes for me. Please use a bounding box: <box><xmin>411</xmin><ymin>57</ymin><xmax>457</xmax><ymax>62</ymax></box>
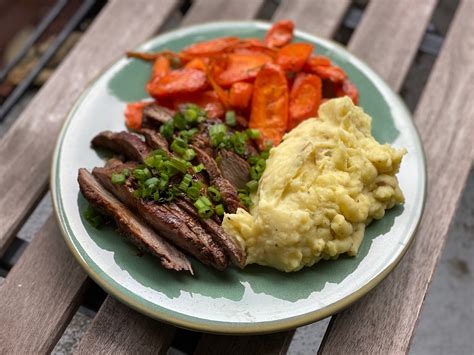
<box><xmin>216</xmin><ymin>150</ymin><xmax>250</xmax><ymax>189</ymax></box>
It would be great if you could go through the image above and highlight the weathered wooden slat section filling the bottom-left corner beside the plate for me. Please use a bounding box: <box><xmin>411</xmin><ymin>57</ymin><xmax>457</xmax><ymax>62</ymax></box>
<box><xmin>0</xmin><ymin>217</ymin><xmax>87</xmax><ymax>354</ymax></box>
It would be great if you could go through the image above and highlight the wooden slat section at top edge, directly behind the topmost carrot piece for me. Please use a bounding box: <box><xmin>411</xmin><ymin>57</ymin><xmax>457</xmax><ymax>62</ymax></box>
<box><xmin>274</xmin><ymin>0</ymin><xmax>351</xmax><ymax>38</ymax></box>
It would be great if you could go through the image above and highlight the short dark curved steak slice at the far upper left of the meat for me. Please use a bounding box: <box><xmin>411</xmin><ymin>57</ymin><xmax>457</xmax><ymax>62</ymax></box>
<box><xmin>91</xmin><ymin>131</ymin><xmax>150</xmax><ymax>162</ymax></box>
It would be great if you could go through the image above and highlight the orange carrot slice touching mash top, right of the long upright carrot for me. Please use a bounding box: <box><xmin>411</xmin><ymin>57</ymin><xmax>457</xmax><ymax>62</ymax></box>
<box><xmin>288</xmin><ymin>73</ymin><xmax>322</xmax><ymax>130</ymax></box>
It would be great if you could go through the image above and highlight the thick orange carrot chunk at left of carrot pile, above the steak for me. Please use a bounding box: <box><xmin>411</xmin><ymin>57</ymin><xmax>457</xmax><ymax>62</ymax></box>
<box><xmin>147</xmin><ymin>68</ymin><xmax>207</xmax><ymax>98</ymax></box>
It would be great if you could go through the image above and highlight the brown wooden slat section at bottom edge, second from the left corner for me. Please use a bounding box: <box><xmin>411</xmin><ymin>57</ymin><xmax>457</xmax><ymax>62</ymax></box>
<box><xmin>76</xmin><ymin>296</ymin><xmax>176</xmax><ymax>354</ymax></box>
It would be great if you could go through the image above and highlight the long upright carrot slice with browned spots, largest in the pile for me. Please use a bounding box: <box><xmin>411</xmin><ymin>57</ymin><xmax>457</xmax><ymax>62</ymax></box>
<box><xmin>249</xmin><ymin>63</ymin><xmax>288</xmax><ymax>147</ymax></box>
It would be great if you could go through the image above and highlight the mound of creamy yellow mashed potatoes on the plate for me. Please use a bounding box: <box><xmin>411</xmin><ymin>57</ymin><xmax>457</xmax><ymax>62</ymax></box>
<box><xmin>222</xmin><ymin>97</ymin><xmax>406</xmax><ymax>272</ymax></box>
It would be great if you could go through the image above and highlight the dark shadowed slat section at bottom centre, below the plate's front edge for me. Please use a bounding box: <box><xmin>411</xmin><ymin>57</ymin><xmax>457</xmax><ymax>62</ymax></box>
<box><xmin>194</xmin><ymin>330</ymin><xmax>294</xmax><ymax>355</ymax></box>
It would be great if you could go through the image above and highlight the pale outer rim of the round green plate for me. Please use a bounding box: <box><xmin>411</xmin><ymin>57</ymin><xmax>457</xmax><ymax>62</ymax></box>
<box><xmin>50</xmin><ymin>21</ymin><xmax>427</xmax><ymax>335</ymax></box>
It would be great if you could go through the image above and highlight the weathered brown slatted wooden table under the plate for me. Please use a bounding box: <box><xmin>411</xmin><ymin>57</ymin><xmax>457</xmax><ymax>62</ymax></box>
<box><xmin>0</xmin><ymin>0</ymin><xmax>474</xmax><ymax>354</ymax></box>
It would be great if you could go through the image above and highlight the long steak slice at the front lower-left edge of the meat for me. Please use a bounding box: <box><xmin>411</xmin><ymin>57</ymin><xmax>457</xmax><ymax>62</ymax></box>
<box><xmin>77</xmin><ymin>169</ymin><xmax>193</xmax><ymax>274</ymax></box>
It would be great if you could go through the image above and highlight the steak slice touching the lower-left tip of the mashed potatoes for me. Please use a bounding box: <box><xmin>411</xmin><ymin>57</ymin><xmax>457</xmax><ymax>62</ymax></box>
<box><xmin>176</xmin><ymin>198</ymin><xmax>245</xmax><ymax>268</ymax></box>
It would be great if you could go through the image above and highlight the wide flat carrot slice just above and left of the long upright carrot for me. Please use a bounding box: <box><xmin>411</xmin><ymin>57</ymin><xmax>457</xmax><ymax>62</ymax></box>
<box><xmin>216</xmin><ymin>53</ymin><xmax>272</xmax><ymax>87</ymax></box>
